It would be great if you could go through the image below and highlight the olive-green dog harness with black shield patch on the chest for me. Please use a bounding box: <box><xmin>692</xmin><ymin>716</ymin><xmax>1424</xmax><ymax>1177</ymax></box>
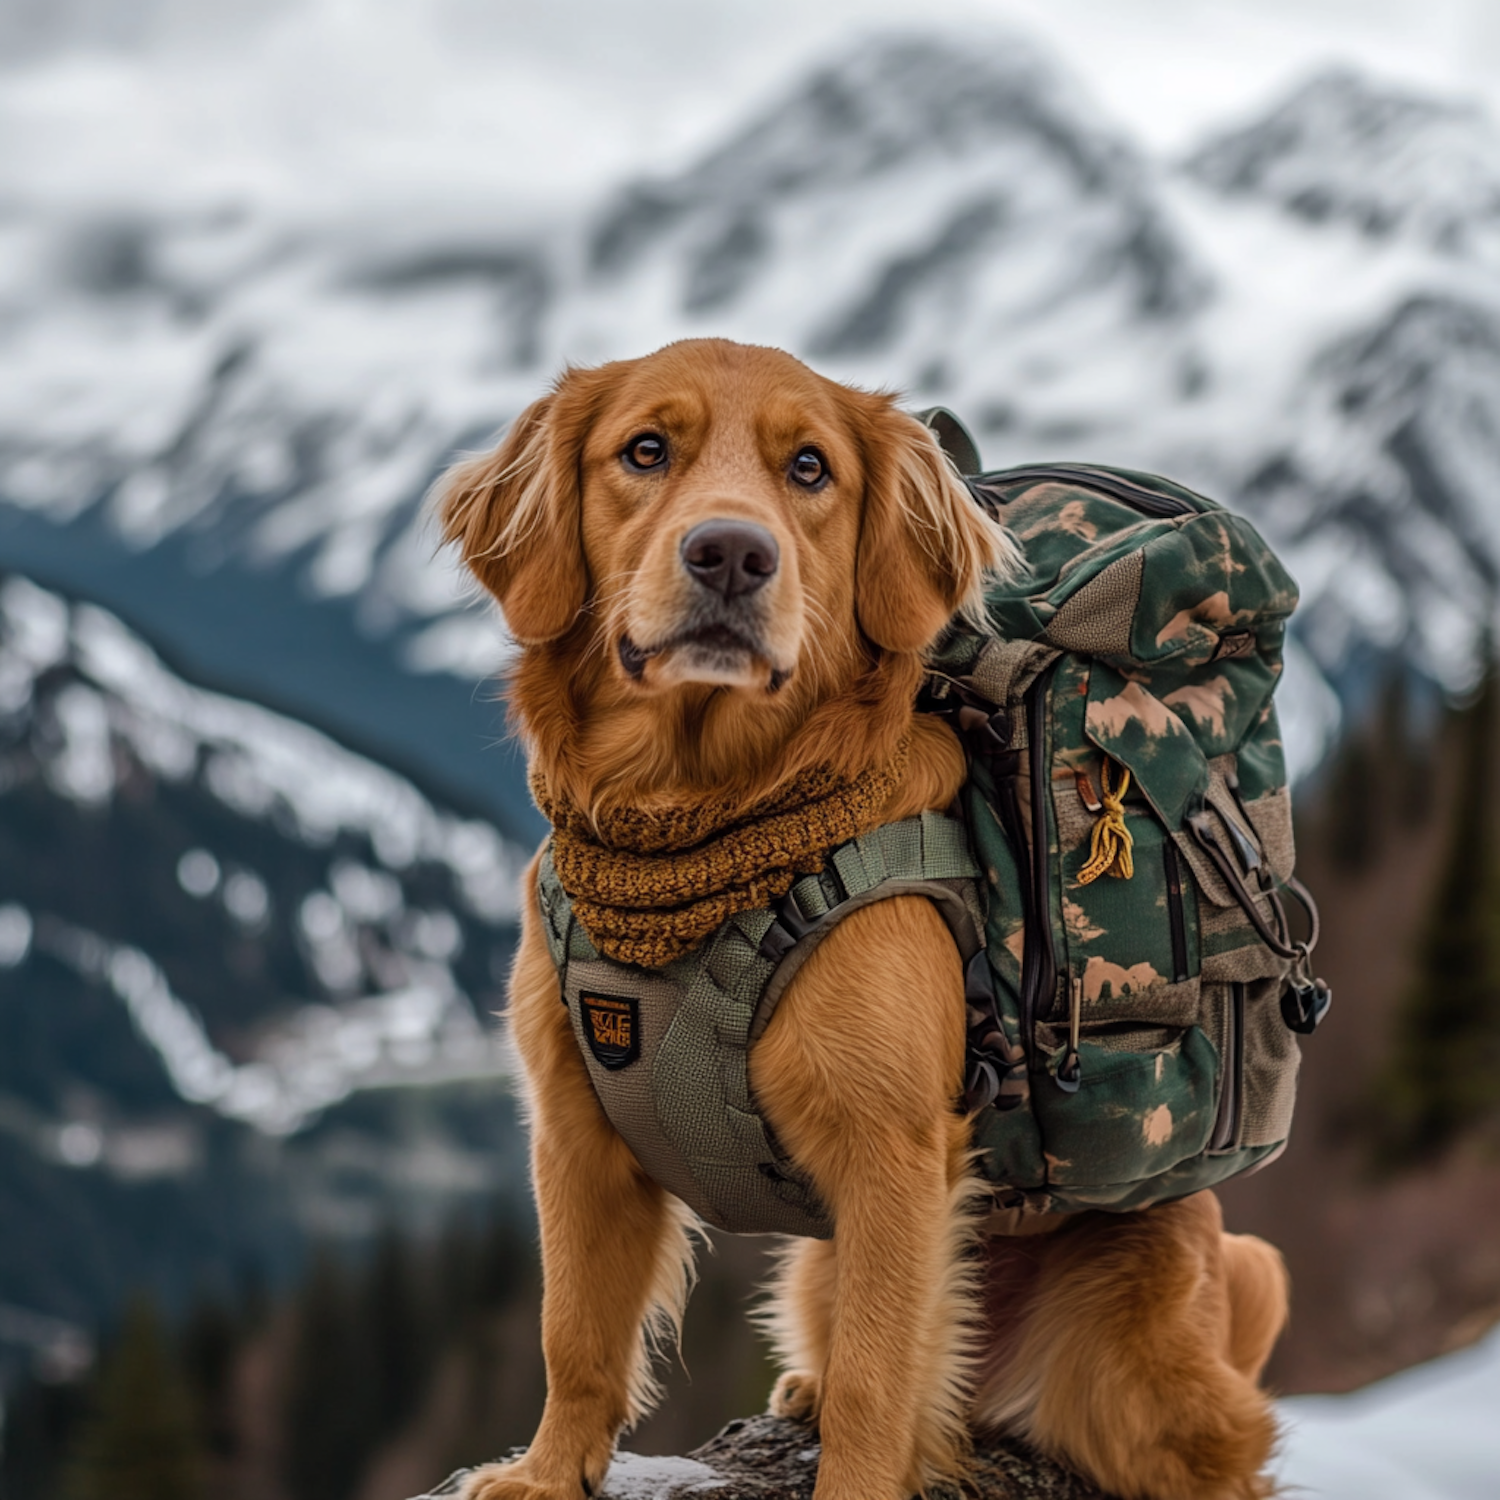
<box><xmin>537</xmin><ymin>813</ymin><xmax>984</xmax><ymax>1239</ymax></box>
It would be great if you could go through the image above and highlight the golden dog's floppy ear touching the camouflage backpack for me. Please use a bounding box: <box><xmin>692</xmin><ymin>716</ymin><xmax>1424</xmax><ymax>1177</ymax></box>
<box><xmin>855</xmin><ymin>396</ymin><xmax>1019</xmax><ymax>651</ymax></box>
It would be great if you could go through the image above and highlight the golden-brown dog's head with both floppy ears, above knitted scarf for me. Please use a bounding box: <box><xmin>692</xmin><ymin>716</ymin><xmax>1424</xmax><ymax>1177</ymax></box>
<box><xmin>440</xmin><ymin>339</ymin><xmax>1013</xmax><ymax>698</ymax></box>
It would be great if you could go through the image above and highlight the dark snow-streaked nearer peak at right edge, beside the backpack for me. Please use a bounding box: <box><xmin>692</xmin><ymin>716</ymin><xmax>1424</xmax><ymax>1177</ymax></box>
<box><xmin>1236</xmin><ymin>290</ymin><xmax>1500</xmax><ymax>699</ymax></box>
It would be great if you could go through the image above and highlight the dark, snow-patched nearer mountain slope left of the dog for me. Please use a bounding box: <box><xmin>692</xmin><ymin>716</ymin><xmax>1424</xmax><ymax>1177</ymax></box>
<box><xmin>0</xmin><ymin>575</ymin><xmax>524</xmax><ymax>1332</ymax></box>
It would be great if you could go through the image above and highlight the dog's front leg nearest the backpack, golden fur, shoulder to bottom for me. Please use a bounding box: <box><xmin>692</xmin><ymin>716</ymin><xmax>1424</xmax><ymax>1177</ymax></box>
<box><xmin>752</xmin><ymin>897</ymin><xmax>972</xmax><ymax>1500</ymax></box>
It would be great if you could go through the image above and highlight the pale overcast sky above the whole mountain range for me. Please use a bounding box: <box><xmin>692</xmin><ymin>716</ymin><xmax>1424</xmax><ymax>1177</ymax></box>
<box><xmin>0</xmin><ymin>0</ymin><xmax>1500</xmax><ymax>212</ymax></box>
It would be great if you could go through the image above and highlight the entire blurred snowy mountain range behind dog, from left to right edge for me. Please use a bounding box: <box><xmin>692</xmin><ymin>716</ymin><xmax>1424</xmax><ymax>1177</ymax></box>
<box><xmin>0</xmin><ymin>33</ymin><xmax>1500</xmax><ymax>798</ymax></box>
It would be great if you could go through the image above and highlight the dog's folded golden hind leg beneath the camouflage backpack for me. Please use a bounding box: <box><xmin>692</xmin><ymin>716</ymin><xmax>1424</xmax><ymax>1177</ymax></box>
<box><xmin>975</xmin><ymin>1193</ymin><xmax>1284</xmax><ymax>1500</ymax></box>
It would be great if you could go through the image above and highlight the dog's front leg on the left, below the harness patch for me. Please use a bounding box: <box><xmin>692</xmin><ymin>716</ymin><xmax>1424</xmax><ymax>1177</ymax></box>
<box><xmin>464</xmin><ymin>876</ymin><xmax>692</xmax><ymax>1500</ymax></box>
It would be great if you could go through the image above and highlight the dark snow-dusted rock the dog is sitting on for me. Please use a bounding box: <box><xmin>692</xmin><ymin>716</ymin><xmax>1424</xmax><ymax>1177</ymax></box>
<box><xmin>419</xmin><ymin>1416</ymin><xmax>1109</xmax><ymax>1500</ymax></box>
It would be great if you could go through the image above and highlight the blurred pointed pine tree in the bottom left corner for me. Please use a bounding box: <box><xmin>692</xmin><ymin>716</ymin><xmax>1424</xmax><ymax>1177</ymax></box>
<box><xmin>63</xmin><ymin>1298</ymin><xmax>206</xmax><ymax>1500</ymax></box>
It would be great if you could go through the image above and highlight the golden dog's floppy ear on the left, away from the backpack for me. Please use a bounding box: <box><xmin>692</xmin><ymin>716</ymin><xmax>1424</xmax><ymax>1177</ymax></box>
<box><xmin>434</xmin><ymin>374</ymin><xmax>591</xmax><ymax>645</ymax></box>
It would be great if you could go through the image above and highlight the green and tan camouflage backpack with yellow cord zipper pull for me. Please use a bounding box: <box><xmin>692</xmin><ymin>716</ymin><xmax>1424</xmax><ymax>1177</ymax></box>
<box><xmin>921</xmin><ymin>413</ymin><xmax>1329</xmax><ymax>1214</ymax></box>
